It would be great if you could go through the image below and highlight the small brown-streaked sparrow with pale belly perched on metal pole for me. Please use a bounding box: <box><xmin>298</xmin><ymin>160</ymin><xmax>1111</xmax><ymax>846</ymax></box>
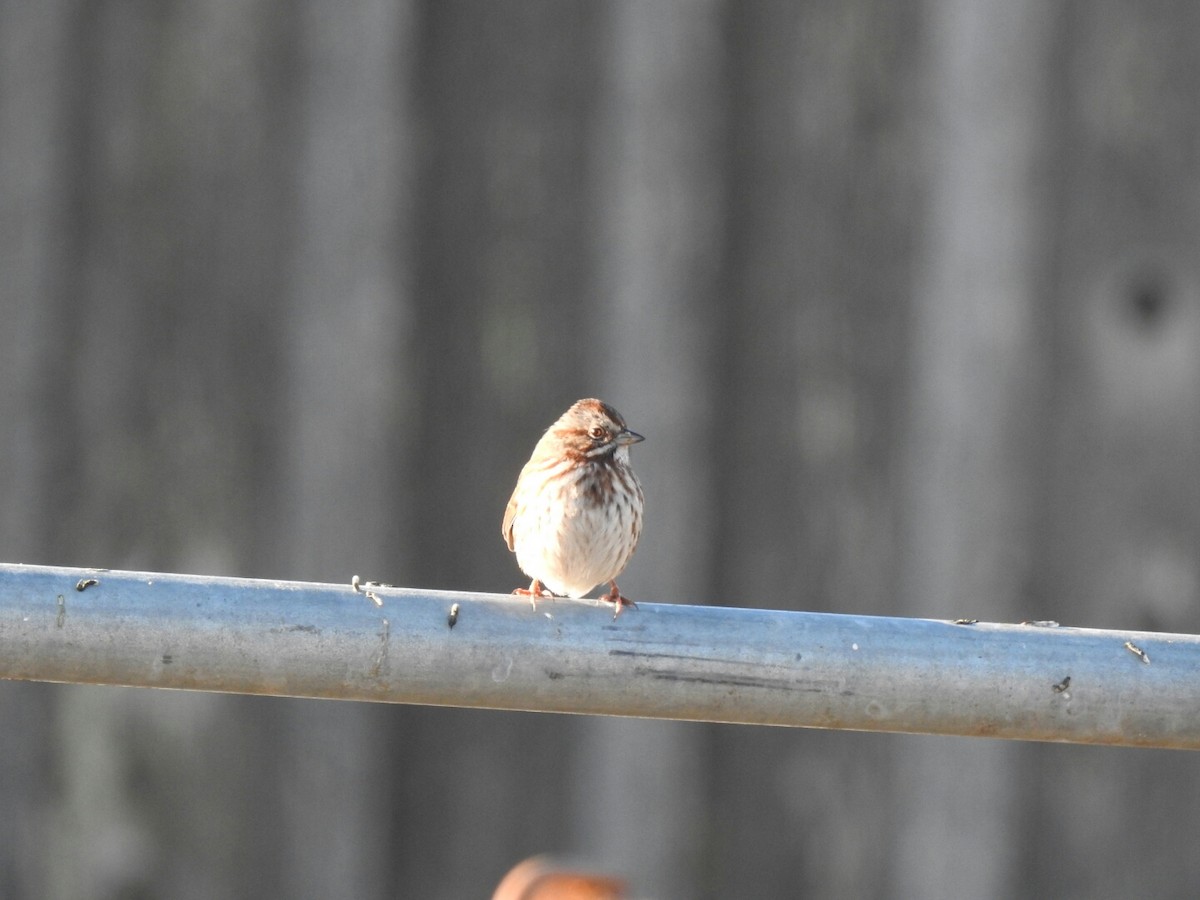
<box><xmin>500</xmin><ymin>400</ymin><xmax>644</xmax><ymax>618</ymax></box>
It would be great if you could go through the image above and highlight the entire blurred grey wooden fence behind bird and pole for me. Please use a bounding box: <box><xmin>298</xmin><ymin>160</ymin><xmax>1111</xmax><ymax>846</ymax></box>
<box><xmin>0</xmin><ymin>0</ymin><xmax>1200</xmax><ymax>899</ymax></box>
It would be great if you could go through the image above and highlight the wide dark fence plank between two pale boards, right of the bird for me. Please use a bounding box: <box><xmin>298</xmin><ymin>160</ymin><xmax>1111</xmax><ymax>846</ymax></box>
<box><xmin>706</xmin><ymin>2</ymin><xmax>919</xmax><ymax>896</ymax></box>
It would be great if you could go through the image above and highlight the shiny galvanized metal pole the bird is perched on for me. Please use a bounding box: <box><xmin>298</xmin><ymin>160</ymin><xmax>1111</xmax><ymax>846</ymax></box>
<box><xmin>0</xmin><ymin>565</ymin><xmax>1200</xmax><ymax>750</ymax></box>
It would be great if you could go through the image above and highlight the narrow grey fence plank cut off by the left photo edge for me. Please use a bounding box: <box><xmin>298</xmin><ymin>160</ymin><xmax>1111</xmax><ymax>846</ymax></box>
<box><xmin>0</xmin><ymin>4</ymin><xmax>76</xmax><ymax>898</ymax></box>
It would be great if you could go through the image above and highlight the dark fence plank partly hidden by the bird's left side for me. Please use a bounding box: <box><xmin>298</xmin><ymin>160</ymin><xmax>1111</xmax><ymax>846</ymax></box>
<box><xmin>386</xmin><ymin>1</ymin><xmax>604</xmax><ymax>900</ymax></box>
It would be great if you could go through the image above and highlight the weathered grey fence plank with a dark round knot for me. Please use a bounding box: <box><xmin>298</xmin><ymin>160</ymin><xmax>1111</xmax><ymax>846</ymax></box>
<box><xmin>1020</xmin><ymin>2</ymin><xmax>1200</xmax><ymax>896</ymax></box>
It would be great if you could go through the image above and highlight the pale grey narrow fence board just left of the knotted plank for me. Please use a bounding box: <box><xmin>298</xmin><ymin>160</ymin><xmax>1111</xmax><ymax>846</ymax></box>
<box><xmin>893</xmin><ymin>2</ymin><xmax>1067</xmax><ymax>898</ymax></box>
